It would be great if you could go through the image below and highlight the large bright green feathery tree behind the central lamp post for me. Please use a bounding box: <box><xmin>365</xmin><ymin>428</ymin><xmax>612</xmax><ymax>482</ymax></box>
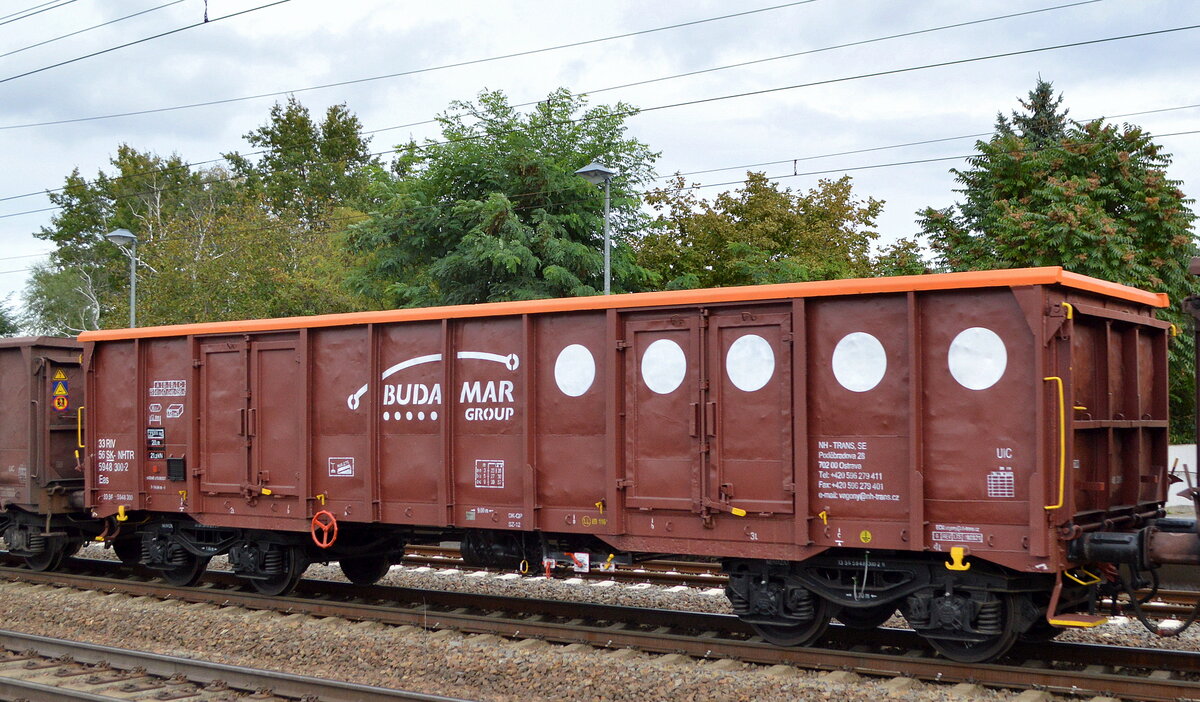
<box><xmin>348</xmin><ymin>89</ymin><xmax>658</xmax><ymax>307</ymax></box>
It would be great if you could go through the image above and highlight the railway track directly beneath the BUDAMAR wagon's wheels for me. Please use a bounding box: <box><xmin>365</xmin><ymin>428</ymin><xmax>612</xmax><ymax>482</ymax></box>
<box><xmin>0</xmin><ymin>560</ymin><xmax>1200</xmax><ymax>702</ymax></box>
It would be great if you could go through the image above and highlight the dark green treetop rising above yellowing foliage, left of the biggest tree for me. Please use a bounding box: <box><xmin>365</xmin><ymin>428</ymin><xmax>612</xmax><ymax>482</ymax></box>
<box><xmin>224</xmin><ymin>97</ymin><xmax>379</xmax><ymax>226</ymax></box>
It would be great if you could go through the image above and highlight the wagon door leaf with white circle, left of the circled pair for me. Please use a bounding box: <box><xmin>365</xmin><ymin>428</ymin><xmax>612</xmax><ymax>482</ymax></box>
<box><xmin>625</xmin><ymin>313</ymin><xmax>703</xmax><ymax>511</ymax></box>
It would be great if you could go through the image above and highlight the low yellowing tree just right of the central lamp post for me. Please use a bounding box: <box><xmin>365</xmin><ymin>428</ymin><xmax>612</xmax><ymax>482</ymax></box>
<box><xmin>636</xmin><ymin>173</ymin><xmax>883</xmax><ymax>289</ymax></box>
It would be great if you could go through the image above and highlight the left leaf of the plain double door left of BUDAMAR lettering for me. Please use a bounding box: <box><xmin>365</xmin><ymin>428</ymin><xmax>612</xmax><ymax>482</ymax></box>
<box><xmin>199</xmin><ymin>341</ymin><xmax>250</xmax><ymax>494</ymax></box>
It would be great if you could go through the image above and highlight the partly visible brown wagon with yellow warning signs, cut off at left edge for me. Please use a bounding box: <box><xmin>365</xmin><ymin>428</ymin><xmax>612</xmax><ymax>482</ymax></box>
<box><xmin>0</xmin><ymin>336</ymin><xmax>95</xmax><ymax>570</ymax></box>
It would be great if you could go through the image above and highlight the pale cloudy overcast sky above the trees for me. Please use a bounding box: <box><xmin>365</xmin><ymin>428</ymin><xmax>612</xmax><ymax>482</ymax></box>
<box><xmin>0</xmin><ymin>0</ymin><xmax>1200</xmax><ymax>305</ymax></box>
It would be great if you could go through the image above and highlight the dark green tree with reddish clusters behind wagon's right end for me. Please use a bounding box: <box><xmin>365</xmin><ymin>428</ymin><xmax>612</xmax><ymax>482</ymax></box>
<box><xmin>918</xmin><ymin>80</ymin><xmax>1198</xmax><ymax>438</ymax></box>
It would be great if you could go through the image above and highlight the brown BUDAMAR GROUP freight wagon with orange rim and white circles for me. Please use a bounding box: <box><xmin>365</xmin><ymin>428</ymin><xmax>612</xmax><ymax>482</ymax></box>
<box><xmin>80</xmin><ymin>268</ymin><xmax>1170</xmax><ymax>659</ymax></box>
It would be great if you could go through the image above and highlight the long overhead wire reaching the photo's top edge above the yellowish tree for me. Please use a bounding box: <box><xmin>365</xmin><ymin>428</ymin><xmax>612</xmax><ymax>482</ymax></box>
<box><xmin>0</xmin><ymin>0</ymin><xmax>816</xmax><ymax>131</ymax></box>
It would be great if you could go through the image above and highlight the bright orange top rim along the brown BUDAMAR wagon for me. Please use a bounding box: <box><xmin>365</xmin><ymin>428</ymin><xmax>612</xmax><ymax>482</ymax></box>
<box><xmin>79</xmin><ymin>266</ymin><xmax>1170</xmax><ymax>342</ymax></box>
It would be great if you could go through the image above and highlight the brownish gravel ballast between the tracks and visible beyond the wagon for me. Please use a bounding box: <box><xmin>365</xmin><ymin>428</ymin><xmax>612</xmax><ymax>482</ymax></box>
<box><xmin>7</xmin><ymin>546</ymin><xmax>1200</xmax><ymax>701</ymax></box>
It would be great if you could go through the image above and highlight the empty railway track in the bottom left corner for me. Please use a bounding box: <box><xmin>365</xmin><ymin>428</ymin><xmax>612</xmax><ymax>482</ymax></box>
<box><xmin>0</xmin><ymin>630</ymin><xmax>461</xmax><ymax>702</ymax></box>
